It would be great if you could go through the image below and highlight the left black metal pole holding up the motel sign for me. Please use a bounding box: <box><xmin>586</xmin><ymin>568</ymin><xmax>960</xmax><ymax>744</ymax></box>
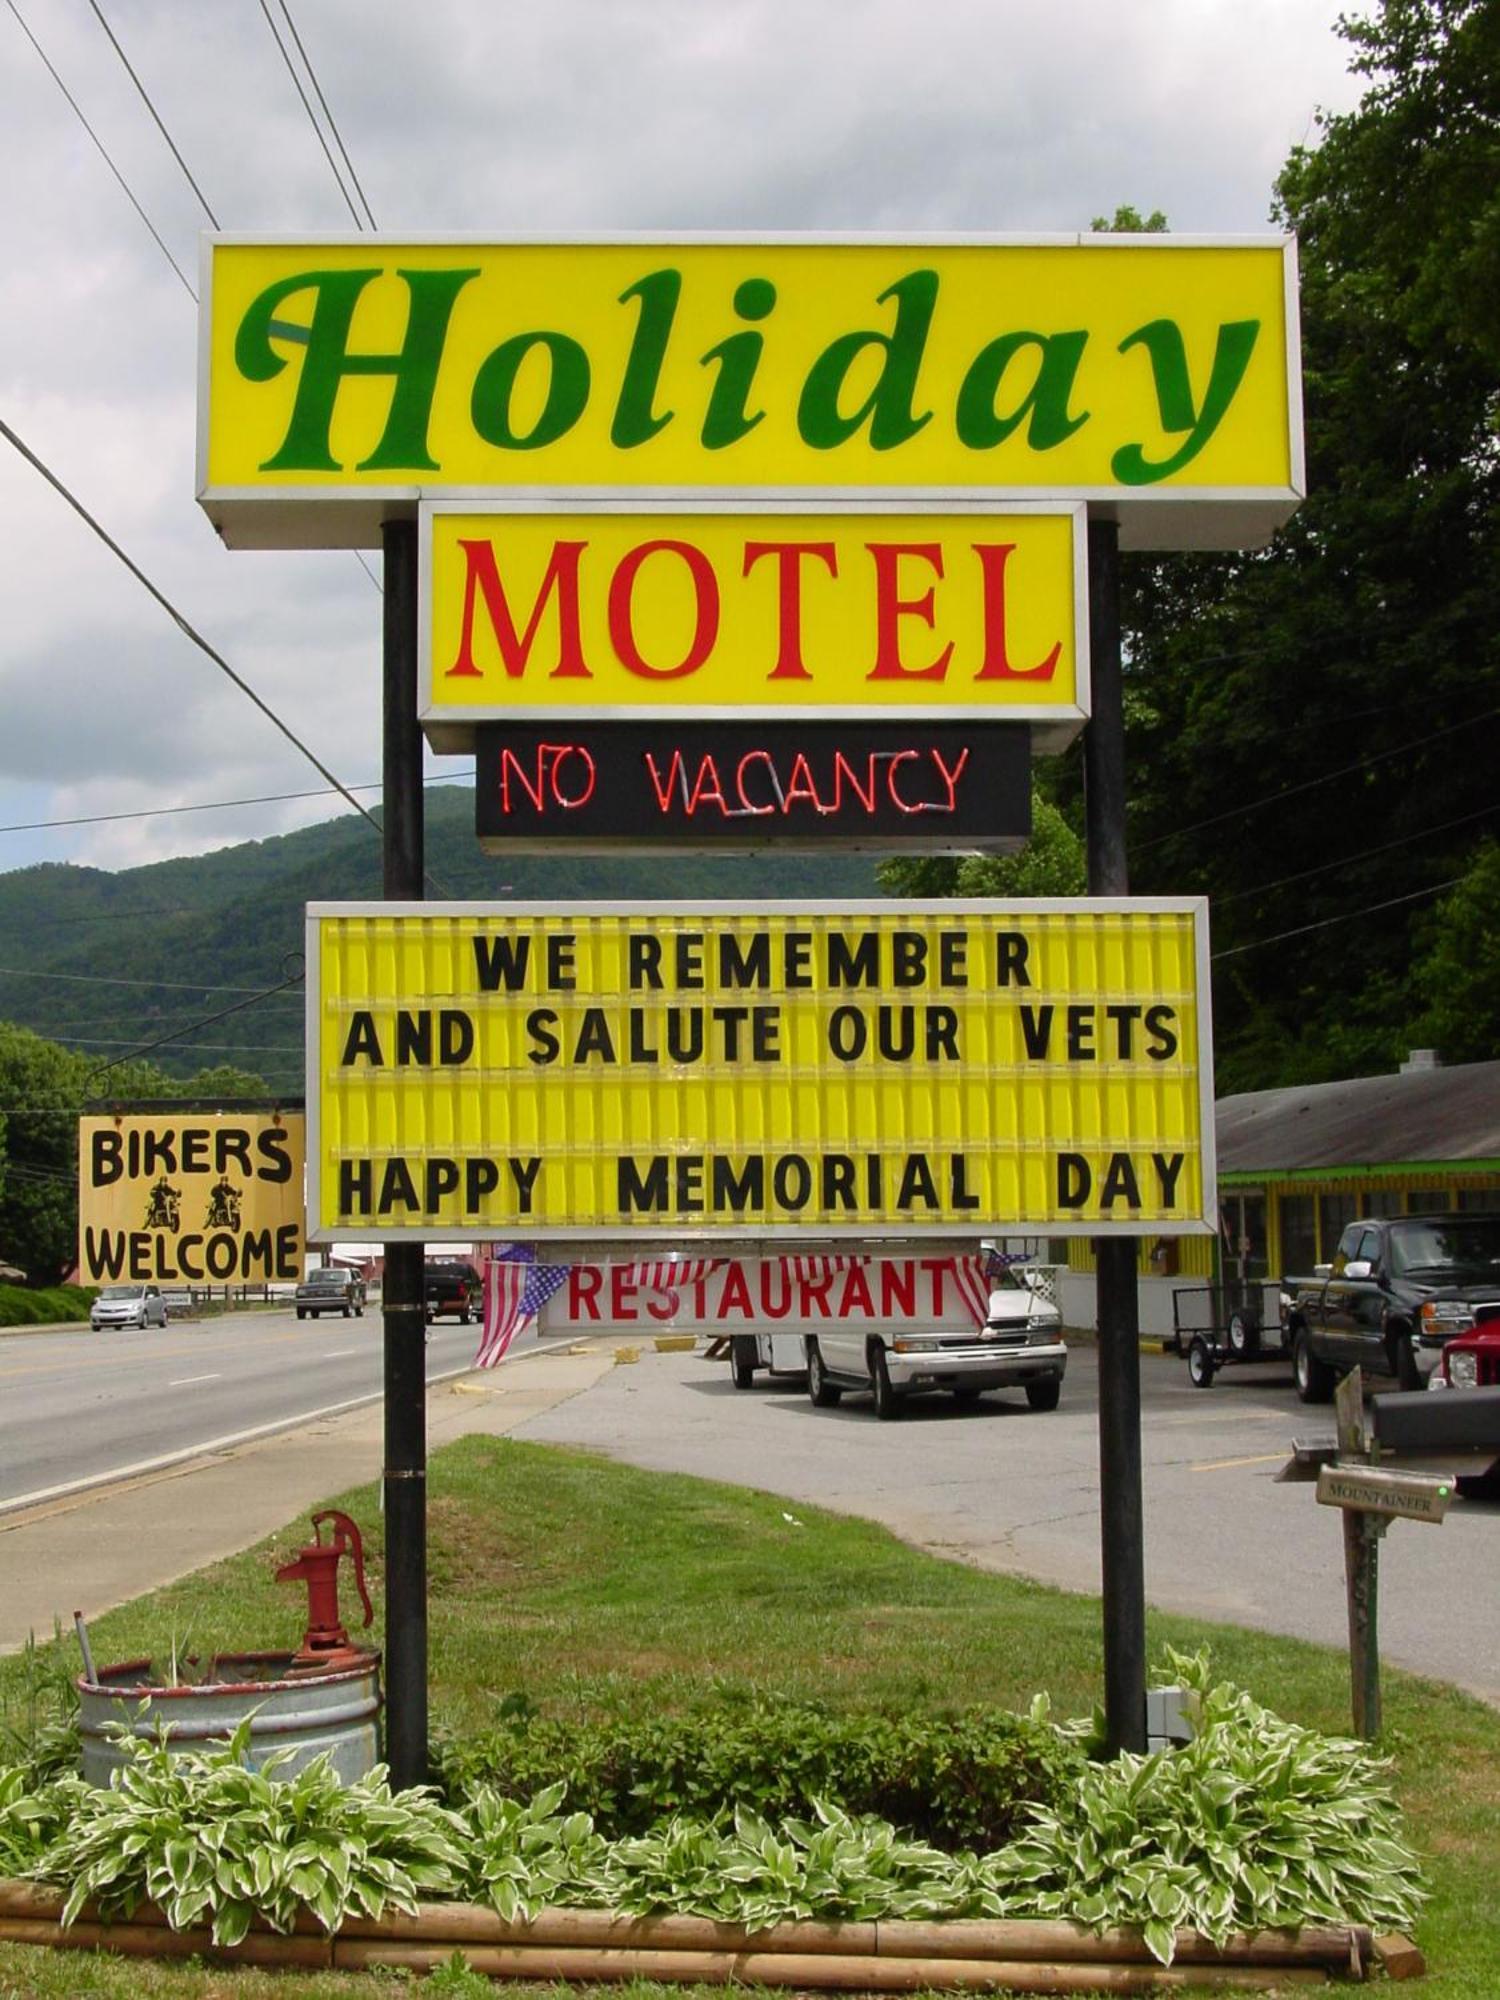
<box><xmin>382</xmin><ymin>520</ymin><xmax>428</xmax><ymax>1788</ymax></box>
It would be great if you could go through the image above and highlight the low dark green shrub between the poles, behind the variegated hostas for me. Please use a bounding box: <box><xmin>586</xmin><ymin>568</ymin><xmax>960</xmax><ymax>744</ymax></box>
<box><xmin>438</xmin><ymin>1702</ymin><xmax>1082</xmax><ymax>1852</ymax></box>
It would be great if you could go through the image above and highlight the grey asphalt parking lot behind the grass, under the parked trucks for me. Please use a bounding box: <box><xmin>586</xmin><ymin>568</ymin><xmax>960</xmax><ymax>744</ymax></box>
<box><xmin>516</xmin><ymin>1346</ymin><xmax>1500</xmax><ymax>1702</ymax></box>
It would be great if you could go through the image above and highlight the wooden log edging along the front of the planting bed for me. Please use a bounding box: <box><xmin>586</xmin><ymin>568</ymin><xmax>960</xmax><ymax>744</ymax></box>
<box><xmin>0</xmin><ymin>1882</ymin><xmax>1424</xmax><ymax>1994</ymax></box>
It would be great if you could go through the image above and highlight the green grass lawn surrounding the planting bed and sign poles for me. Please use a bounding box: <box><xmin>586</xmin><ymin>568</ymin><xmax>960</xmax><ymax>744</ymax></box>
<box><xmin>0</xmin><ymin>1438</ymin><xmax>1500</xmax><ymax>2000</ymax></box>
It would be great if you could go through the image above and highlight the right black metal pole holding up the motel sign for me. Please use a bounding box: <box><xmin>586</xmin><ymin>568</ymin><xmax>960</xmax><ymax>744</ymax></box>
<box><xmin>1084</xmin><ymin>520</ymin><xmax>1146</xmax><ymax>1754</ymax></box>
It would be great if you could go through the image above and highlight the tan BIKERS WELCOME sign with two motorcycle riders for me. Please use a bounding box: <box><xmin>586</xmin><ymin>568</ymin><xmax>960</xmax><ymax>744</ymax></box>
<box><xmin>78</xmin><ymin>1106</ymin><xmax>304</xmax><ymax>1284</ymax></box>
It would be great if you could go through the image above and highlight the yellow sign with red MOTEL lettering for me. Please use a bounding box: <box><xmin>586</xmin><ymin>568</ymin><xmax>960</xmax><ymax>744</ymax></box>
<box><xmin>420</xmin><ymin>508</ymin><xmax>1088</xmax><ymax>750</ymax></box>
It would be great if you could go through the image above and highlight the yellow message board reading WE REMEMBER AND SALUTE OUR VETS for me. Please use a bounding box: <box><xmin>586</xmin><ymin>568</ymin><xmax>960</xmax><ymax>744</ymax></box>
<box><xmin>308</xmin><ymin>898</ymin><xmax>1214</xmax><ymax>1242</ymax></box>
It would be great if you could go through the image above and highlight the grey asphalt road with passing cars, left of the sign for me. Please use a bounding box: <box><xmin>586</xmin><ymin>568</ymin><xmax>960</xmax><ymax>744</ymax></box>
<box><xmin>0</xmin><ymin>1308</ymin><xmax>478</xmax><ymax>1508</ymax></box>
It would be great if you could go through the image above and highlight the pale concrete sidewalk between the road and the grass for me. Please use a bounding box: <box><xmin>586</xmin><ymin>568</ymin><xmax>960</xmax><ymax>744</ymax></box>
<box><xmin>0</xmin><ymin>1340</ymin><xmax>616</xmax><ymax>1654</ymax></box>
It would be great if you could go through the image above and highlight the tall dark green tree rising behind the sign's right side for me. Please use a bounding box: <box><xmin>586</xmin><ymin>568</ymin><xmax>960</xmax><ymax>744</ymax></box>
<box><xmin>1124</xmin><ymin>0</ymin><xmax>1500</xmax><ymax>1092</ymax></box>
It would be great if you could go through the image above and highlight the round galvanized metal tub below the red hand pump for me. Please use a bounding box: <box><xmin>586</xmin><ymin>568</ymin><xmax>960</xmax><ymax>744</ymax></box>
<box><xmin>78</xmin><ymin>1650</ymin><xmax>380</xmax><ymax>1788</ymax></box>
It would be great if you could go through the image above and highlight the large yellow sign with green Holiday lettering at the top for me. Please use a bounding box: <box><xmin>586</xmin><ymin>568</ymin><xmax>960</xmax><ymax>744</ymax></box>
<box><xmin>198</xmin><ymin>236</ymin><xmax>1302</xmax><ymax>548</ymax></box>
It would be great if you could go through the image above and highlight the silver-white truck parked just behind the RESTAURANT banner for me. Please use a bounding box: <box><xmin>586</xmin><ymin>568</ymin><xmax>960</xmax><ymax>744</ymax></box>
<box><xmin>808</xmin><ymin>1270</ymin><xmax>1068</xmax><ymax>1422</ymax></box>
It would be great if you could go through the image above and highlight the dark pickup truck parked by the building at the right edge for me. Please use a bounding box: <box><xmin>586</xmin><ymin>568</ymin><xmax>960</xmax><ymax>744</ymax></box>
<box><xmin>1282</xmin><ymin>1212</ymin><xmax>1500</xmax><ymax>1402</ymax></box>
